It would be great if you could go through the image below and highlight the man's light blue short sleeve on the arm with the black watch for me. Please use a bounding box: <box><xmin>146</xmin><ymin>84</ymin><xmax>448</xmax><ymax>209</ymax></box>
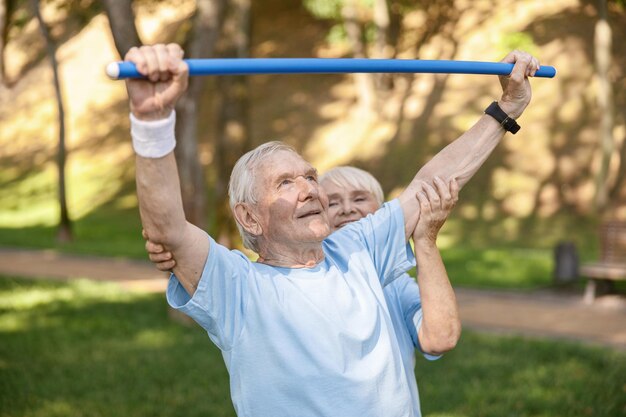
<box><xmin>338</xmin><ymin>199</ymin><xmax>415</xmax><ymax>287</ymax></box>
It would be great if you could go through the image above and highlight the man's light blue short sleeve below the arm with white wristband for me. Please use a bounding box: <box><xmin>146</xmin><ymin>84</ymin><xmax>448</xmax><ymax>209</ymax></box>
<box><xmin>167</xmin><ymin>235</ymin><xmax>250</xmax><ymax>350</ymax></box>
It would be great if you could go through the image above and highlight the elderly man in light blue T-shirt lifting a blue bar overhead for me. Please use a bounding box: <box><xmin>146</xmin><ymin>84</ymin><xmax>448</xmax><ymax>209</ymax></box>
<box><xmin>126</xmin><ymin>44</ymin><xmax>539</xmax><ymax>416</ymax></box>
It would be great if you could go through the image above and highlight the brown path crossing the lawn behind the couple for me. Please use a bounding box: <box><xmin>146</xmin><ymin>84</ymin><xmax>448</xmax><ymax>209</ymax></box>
<box><xmin>0</xmin><ymin>248</ymin><xmax>626</xmax><ymax>350</ymax></box>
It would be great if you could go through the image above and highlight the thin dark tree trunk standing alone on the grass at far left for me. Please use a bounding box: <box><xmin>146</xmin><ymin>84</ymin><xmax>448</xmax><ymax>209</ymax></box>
<box><xmin>31</xmin><ymin>0</ymin><xmax>72</xmax><ymax>242</ymax></box>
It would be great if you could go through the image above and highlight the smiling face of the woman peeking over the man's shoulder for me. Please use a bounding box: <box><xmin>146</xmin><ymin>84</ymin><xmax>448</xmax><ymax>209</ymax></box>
<box><xmin>323</xmin><ymin>181</ymin><xmax>379</xmax><ymax>232</ymax></box>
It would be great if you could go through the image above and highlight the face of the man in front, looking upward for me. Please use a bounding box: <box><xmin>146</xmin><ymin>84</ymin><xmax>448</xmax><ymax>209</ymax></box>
<box><xmin>256</xmin><ymin>151</ymin><xmax>331</xmax><ymax>245</ymax></box>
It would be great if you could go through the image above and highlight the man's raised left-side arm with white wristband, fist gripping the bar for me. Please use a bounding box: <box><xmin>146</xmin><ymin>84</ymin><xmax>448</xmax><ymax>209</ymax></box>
<box><xmin>125</xmin><ymin>44</ymin><xmax>209</xmax><ymax>295</ymax></box>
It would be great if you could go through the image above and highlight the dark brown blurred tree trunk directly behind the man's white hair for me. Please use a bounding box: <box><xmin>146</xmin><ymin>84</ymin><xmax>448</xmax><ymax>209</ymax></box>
<box><xmin>215</xmin><ymin>0</ymin><xmax>251</xmax><ymax>246</ymax></box>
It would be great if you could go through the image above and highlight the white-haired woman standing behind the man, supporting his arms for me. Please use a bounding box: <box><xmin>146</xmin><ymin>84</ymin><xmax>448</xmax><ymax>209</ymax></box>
<box><xmin>144</xmin><ymin>166</ymin><xmax>460</xmax><ymax>410</ymax></box>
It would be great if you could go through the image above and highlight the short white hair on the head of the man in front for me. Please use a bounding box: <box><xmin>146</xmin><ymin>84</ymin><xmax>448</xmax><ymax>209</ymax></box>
<box><xmin>228</xmin><ymin>141</ymin><xmax>298</xmax><ymax>253</ymax></box>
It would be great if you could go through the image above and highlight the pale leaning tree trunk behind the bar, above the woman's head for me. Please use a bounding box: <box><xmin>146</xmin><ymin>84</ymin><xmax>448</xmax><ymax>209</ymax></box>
<box><xmin>341</xmin><ymin>0</ymin><xmax>376</xmax><ymax>112</ymax></box>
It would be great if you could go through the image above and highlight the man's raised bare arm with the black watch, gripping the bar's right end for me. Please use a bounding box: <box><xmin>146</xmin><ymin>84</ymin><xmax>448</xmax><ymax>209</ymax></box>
<box><xmin>400</xmin><ymin>51</ymin><xmax>539</xmax><ymax>240</ymax></box>
